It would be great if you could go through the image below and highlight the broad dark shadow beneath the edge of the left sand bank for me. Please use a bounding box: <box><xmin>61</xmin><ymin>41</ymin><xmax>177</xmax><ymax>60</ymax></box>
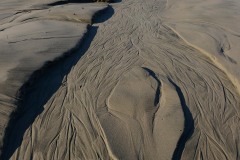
<box><xmin>0</xmin><ymin>5</ymin><xmax>113</xmax><ymax>160</ymax></box>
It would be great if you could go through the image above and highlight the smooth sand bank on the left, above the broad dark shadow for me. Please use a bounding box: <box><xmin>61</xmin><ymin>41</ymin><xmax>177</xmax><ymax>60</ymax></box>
<box><xmin>0</xmin><ymin>0</ymin><xmax>107</xmax><ymax>154</ymax></box>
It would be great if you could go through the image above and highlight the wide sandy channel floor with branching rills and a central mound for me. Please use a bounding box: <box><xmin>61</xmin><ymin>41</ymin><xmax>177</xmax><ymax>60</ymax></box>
<box><xmin>0</xmin><ymin>0</ymin><xmax>240</xmax><ymax>160</ymax></box>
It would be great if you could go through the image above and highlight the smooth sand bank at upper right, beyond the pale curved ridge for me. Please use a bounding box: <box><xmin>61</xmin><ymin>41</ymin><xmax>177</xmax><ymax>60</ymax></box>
<box><xmin>162</xmin><ymin>0</ymin><xmax>240</xmax><ymax>84</ymax></box>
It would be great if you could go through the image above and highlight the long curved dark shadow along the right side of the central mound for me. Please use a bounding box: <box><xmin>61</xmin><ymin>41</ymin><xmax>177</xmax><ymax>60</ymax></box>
<box><xmin>168</xmin><ymin>78</ymin><xmax>194</xmax><ymax>160</ymax></box>
